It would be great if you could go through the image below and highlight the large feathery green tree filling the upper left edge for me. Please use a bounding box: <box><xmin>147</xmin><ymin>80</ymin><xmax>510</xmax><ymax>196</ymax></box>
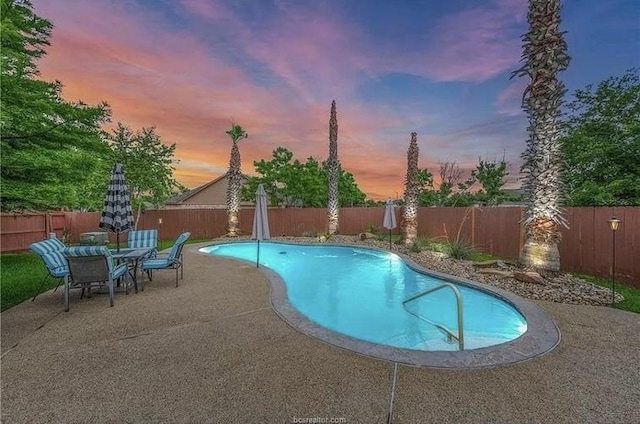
<box><xmin>0</xmin><ymin>0</ymin><xmax>110</xmax><ymax>210</ymax></box>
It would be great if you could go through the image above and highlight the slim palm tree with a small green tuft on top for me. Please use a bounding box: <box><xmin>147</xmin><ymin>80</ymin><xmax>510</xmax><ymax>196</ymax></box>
<box><xmin>227</xmin><ymin>122</ymin><xmax>249</xmax><ymax>237</ymax></box>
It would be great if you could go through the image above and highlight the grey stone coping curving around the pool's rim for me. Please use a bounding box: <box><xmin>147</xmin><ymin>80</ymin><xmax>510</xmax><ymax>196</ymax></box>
<box><xmin>194</xmin><ymin>240</ymin><xmax>561</xmax><ymax>369</ymax></box>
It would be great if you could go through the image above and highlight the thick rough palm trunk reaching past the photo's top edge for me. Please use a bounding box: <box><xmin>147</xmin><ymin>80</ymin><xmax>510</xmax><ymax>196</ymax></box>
<box><xmin>512</xmin><ymin>0</ymin><xmax>570</xmax><ymax>271</ymax></box>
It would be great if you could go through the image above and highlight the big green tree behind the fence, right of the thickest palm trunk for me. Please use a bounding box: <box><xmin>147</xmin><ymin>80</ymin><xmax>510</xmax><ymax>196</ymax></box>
<box><xmin>560</xmin><ymin>68</ymin><xmax>640</xmax><ymax>206</ymax></box>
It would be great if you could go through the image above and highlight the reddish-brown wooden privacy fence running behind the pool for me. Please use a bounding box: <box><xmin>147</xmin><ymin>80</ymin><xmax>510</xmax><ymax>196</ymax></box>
<box><xmin>0</xmin><ymin>207</ymin><xmax>640</xmax><ymax>287</ymax></box>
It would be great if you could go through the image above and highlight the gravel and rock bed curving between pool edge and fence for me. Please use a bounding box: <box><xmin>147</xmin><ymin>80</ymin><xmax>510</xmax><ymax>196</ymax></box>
<box><xmin>220</xmin><ymin>235</ymin><xmax>624</xmax><ymax>306</ymax></box>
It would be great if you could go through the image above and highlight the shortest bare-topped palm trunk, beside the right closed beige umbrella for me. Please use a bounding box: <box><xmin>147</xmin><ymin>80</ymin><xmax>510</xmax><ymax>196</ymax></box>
<box><xmin>400</xmin><ymin>132</ymin><xmax>420</xmax><ymax>245</ymax></box>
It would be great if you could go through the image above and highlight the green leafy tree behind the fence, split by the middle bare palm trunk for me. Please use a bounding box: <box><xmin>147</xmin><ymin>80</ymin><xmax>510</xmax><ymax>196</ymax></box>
<box><xmin>242</xmin><ymin>146</ymin><xmax>366</xmax><ymax>207</ymax></box>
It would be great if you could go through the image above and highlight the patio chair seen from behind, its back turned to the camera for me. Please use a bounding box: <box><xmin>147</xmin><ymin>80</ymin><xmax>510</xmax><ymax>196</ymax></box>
<box><xmin>62</xmin><ymin>246</ymin><xmax>127</xmax><ymax>312</ymax></box>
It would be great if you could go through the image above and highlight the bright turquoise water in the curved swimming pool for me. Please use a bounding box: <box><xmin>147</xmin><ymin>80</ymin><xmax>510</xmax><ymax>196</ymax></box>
<box><xmin>200</xmin><ymin>242</ymin><xmax>527</xmax><ymax>350</ymax></box>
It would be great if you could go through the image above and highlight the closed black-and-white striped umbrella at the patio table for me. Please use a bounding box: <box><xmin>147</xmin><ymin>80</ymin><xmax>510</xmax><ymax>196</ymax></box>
<box><xmin>98</xmin><ymin>163</ymin><xmax>135</xmax><ymax>250</ymax></box>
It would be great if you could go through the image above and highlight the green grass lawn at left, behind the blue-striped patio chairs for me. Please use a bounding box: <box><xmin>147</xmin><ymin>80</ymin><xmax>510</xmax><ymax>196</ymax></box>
<box><xmin>0</xmin><ymin>239</ymin><xmax>210</xmax><ymax>311</ymax></box>
